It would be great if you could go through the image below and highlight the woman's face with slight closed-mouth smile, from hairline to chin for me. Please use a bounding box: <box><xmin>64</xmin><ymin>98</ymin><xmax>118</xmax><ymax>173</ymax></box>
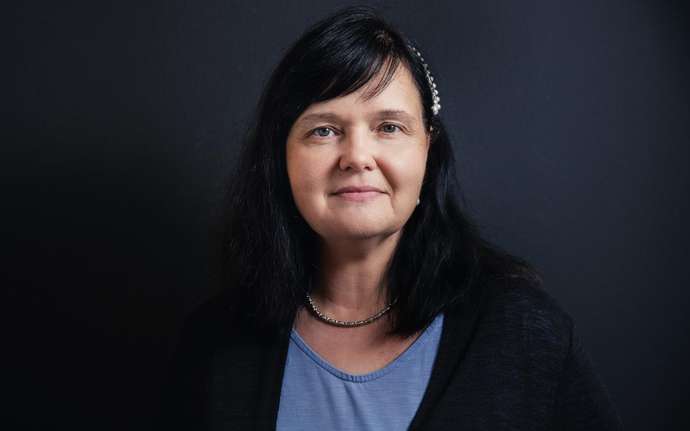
<box><xmin>286</xmin><ymin>65</ymin><xmax>429</xmax><ymax>241</ymax></box>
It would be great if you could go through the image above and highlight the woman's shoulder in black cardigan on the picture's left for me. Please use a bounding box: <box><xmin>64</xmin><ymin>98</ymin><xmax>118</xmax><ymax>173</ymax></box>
<box><xmin>163</xmin><ymin>295</ymin><xmax>287</xmax><ymax>429</ymax></box>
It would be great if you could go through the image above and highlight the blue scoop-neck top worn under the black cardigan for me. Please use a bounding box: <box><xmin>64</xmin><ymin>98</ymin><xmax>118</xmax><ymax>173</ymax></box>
<box><xmin>276</xmin><ymin>314</ymin><xmax>443</xmax><ymax>431</ymax></box>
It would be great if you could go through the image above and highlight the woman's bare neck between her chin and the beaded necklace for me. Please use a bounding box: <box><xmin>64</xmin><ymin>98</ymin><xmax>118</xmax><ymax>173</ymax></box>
<box><xmin>312</xmin><ymin>232</ymin><xmax>400</xmax><ymax>320</ymax></box>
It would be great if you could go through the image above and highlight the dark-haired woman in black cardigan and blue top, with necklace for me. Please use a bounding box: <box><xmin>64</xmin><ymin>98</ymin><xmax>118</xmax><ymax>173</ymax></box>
<box><xmin>166</xmin><ymin>7</ymin><xmax>620</xmax><ymax>430</ymax></box>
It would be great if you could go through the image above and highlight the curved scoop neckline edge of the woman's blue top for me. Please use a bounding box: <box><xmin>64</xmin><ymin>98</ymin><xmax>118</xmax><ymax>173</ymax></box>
<box><xmin>290</xmin><ymin>313</ymin><xmax>443</xmax><ymax>383</ymax></box>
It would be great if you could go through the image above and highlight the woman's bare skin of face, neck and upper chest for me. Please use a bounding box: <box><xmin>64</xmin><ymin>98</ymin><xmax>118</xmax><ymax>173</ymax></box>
<box><xmin>286</xmin><ymin>65</ymin><xmax>430</xmax><ymax>374</ymax></box>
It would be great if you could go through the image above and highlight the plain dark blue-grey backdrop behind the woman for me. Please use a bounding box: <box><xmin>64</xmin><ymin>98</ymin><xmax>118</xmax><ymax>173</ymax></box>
<box><xmin>6</xmin><ymin>0</ymin><xmax>690</xmax><ymax>430</ymax></box>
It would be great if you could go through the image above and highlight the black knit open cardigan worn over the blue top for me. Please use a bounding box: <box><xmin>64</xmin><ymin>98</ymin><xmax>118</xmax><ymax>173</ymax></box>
<box><xmin>163</xmin><ymin>279</ymin><xmax>622</xmax><ymax>431</ymax></box>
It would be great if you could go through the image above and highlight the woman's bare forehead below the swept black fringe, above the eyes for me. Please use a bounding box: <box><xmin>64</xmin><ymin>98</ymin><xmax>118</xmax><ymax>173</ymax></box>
<box><xmin>297</xmin><ymin>64</ymin><xmax>422</xmax><ymax>122</ymax></box>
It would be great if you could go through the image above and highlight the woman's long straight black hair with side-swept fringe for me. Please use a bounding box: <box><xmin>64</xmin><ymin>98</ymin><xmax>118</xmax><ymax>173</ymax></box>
<box><xmin>215</xmin><ymin>6</ymin><xmax>539</xmax><ymax>335</ymax></box>
